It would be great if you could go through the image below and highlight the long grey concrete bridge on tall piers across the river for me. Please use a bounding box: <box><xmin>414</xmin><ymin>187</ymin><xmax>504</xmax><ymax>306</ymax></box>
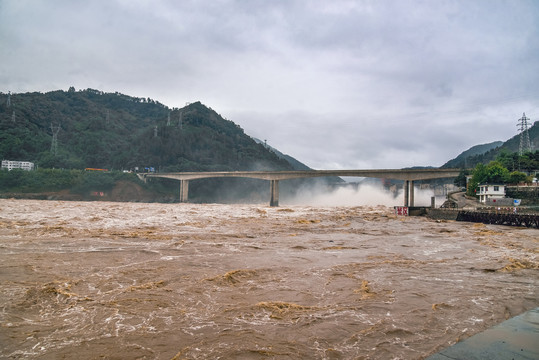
<box><xmin>137</xmin><ymin>169</ymin><xmax>460</xmax><ymax>206</ymax></box>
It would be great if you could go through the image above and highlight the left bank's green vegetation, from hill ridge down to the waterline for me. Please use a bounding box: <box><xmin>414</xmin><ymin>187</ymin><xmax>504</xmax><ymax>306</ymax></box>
<box><xmin>0</xmin><ymin>88</ymin><xmax>332</xmax><ymax>202</ymax></box>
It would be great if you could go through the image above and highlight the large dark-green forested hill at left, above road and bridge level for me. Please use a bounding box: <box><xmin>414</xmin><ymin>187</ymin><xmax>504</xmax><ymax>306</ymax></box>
<box><xmin>0</xmin><ymin>88</ymin><xmax>292</xmax><ymax>171</ymax></box>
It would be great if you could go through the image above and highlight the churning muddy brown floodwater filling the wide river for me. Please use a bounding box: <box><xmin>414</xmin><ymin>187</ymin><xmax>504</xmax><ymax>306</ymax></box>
<box><xmin>0</xmin><ymin>200</ymin><xmax>539</xmax><ymax>359</ymax></box>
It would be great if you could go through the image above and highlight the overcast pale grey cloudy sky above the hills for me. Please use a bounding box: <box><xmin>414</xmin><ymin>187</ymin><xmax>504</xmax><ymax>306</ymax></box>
<box><xmin>0</xmin><ymin>0</ymin><xmax>539</xmax><ymax>169</ymax></box>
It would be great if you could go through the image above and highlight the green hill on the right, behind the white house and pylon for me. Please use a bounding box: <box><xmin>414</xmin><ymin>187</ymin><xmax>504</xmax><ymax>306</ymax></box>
<box><xmin>442</xmin><ymin>121</ymin><xmax>539</xmax><ymax>168</ymax></box>
